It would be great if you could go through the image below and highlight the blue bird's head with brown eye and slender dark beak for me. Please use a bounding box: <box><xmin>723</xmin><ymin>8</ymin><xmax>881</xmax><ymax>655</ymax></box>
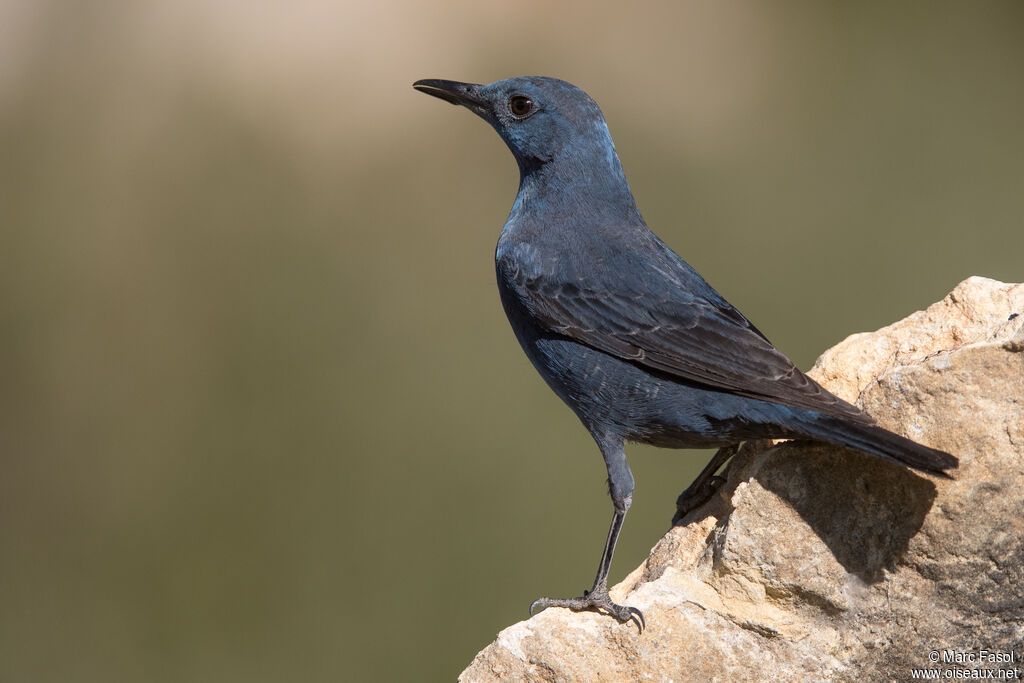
<box><xmin>413</xmin><ymin>76</ymin><xmax>622</xmax><ymax>180</ymax></box>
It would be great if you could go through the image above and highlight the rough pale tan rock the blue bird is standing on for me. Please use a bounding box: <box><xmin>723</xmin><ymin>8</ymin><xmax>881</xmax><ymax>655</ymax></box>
<box><xmin>460</xmin><ymin>278</ymin><xmax>1024</xmax><ymax>682</ymax></box>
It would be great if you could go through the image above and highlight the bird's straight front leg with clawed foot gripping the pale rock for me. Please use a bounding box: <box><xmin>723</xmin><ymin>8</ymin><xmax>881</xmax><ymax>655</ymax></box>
<box><xmin>529</xmin><ymin>435</ymin><xmax>646</xmax><ymax>633</ymax></box>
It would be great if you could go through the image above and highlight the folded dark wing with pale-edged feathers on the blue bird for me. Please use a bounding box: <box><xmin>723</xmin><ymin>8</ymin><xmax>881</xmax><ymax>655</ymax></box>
<box><xmin>502</xmin><ymin>248</ymin><xmax>871</xmax><ymax>423</ymax></box>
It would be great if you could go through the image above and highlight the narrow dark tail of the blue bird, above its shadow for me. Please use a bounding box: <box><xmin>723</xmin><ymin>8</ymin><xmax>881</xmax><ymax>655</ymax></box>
<box><xmin>794</xmin><ymin>414</ymin><xmax>959</xmax><ymax>477</ymax></box>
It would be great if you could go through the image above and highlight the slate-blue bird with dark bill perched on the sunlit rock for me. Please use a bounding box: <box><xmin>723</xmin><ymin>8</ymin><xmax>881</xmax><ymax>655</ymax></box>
<box><xmin>413</xmin><ymin>77</ymin><xmax>957</xmax><ymax>631</ymax></box>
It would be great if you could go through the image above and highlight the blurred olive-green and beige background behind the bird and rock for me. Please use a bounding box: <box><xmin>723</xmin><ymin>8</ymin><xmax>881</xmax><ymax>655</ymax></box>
<box><xmin>0</xmin><ymin>0</ymin><xmax>1024</xmax><ymax>683</ymax></box>
